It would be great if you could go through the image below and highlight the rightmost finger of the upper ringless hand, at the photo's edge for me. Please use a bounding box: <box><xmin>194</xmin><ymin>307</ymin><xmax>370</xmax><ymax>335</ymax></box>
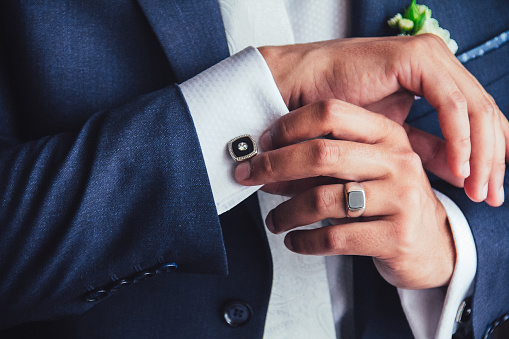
<box><xmin>480</xmin><ymin>115</ymin><xmax>506</xmax><ymax>207</ymax></box>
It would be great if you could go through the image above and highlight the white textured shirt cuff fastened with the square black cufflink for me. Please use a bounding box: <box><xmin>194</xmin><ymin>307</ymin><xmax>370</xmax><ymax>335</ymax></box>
<box><xmin>180</xmin><ymin>47</ymin><xmax>288</xmax><ymax>214</ymax></box>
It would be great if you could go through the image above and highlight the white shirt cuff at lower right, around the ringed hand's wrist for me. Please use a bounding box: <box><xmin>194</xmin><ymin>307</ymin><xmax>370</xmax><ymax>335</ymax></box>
<box><xmin>398</xmin><ymin>190</ymin><xmax>477</xmax><ymax>339</ymax></box>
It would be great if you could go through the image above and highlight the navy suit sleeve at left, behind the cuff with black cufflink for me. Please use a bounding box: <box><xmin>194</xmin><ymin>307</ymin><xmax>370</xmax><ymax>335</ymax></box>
<box><xmin>0</xmin><ymin>56</ymin><xmax>227</xmax><ymax>329</ymax></box>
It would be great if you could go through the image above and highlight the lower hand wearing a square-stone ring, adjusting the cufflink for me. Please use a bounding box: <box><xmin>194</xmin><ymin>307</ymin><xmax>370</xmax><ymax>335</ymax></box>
<box><xmin>235</xmin><ymin>99</ymin><xmax>456</xmax><ymax>289</ymax></box>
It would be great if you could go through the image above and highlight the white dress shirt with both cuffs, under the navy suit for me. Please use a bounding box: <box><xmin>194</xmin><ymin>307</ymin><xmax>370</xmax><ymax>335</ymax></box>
<box><xmin>181</xmin><ymin>0</ymin><xmax>476</xmax><ymax>338</ymax></box>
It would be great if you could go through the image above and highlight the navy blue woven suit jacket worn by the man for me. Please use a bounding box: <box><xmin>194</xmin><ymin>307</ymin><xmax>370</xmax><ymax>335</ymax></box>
<box><xmin>0</xmin><ymin>0</ymin><xmax>509</xmax><ymax>338</ymax></box>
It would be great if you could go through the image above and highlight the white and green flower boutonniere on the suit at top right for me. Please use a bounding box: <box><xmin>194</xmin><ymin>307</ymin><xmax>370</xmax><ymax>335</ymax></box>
<box><xmin>387</xmin><ymin>0</ymin><xmax>458</xmax><ymax>54</ymax></box>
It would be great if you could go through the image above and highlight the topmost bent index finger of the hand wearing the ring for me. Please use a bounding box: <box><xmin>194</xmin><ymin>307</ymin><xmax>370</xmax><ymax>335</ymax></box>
<box><xmin>261</xmin><ymin>99</ymin><xmax>398</xmax><ymax>150</ymax></box>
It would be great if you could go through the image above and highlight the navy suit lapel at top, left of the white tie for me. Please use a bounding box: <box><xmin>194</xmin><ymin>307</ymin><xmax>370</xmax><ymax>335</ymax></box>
<box><xmin>138</xmin><ymin>0</ymin><xmax>229</xmax><ymax>82</ymax></box>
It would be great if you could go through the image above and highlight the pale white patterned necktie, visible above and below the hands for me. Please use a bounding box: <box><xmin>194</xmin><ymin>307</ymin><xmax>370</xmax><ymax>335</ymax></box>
<box><xmin>219</xmin><ymin>0</ymin><xmax>335</xmax><ymax>339</ymax></box>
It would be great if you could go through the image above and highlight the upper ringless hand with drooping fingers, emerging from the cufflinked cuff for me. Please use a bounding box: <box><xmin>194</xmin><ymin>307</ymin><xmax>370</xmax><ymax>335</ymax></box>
<box><xmin>259</xmin><ymin>34</ymin><xmax>509</xmax><ymax>206</ymax></box>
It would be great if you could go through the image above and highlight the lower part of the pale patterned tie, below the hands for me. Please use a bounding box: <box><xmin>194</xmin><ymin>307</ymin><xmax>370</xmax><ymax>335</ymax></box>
<box><xmin>258</xmin><ymin>191</ymin><xmax>335</xmax><ymax>339</ymax></box>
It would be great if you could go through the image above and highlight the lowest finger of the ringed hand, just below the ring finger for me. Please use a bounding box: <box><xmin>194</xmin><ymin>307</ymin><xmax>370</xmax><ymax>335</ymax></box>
<box><xmin>284</xmin><ymin>220</ymin><xmax>393</xmax><ymax>257</ymax></box>
